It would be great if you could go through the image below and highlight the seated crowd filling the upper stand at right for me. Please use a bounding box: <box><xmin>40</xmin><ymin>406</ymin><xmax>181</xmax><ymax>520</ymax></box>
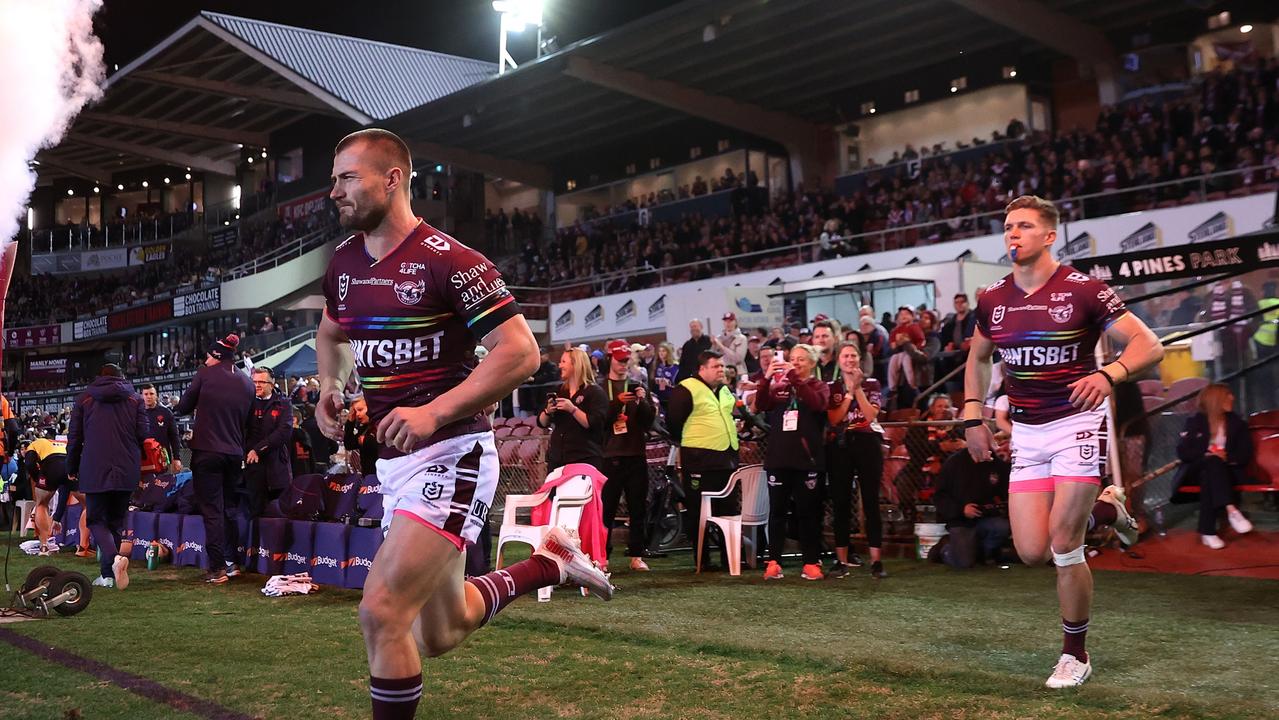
<box><xmin>505</xmin><ymin>59</ymin><xmax>1279</xmax><ymax>292</ymax></box>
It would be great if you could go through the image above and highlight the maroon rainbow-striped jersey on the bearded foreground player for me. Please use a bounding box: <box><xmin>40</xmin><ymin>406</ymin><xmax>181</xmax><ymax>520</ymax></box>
<box><xmin>324</xmin><ymin>223</ymin><xmax>521</xmax><ymax>459</ymax></box>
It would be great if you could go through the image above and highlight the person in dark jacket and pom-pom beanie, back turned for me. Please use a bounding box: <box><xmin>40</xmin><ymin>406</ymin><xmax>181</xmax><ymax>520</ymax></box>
<box><xmin>174</xmin><ymin>333</ymin><xmax>253</xmax><ymax>583</ymax></box>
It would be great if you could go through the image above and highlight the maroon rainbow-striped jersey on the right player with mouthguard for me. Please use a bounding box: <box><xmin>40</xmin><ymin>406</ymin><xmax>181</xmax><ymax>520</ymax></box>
<box><xmin>977</xmin><ymin>265</ymin><xmax>1128</xmax><ymax>425</ymax></box>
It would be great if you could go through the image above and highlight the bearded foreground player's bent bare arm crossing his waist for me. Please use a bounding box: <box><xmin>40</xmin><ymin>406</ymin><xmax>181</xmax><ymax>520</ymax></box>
<box><xmin>377</xmin><ymin>315</ymin><xmax>538</xmax><ymax>453</ymax></box>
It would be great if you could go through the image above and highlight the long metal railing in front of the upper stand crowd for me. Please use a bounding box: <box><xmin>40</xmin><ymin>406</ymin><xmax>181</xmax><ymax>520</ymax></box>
<box><xmin>524</xmin><ymin>165</ymin><xmax>1275</xmax><ymax>294</ymax></box>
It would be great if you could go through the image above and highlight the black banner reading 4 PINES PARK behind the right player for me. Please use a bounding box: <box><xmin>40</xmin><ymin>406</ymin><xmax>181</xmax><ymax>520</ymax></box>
<box><xmin>1071</xmin><ymin>230</ymin><xmax>1279</xmax><ymax>285</ymax></box>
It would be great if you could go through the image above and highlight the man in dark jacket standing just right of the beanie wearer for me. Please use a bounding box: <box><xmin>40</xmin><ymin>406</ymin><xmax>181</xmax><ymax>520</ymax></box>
<box><xmin>244</xmin><ymin>366</ymin><xmax>293</xmax><ymax>518</ymax></box>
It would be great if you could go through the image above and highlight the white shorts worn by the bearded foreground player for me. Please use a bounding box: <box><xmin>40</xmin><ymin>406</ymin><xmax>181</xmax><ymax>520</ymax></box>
<box><xmin>377</xmin><ymin>432</ymin><xmax>498</xmax><ymax>550</ymax></box>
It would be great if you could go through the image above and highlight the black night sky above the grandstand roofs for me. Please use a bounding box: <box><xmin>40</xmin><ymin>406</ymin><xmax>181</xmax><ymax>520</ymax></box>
<box><xmin>97</xmin><ymin>0</ymin><xmax>675</xmax><ymax>74</ymax></box>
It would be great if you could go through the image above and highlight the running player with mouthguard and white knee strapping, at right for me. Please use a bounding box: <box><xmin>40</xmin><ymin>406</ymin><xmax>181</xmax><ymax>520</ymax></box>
<box><xmin>964</xmin><ymin>196</ymin><xmax>1164</xmax><ymax>688</ymax></box>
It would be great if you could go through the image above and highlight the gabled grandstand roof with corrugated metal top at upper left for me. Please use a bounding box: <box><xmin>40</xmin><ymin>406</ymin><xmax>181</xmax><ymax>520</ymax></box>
<box><xmin>37</xmin><ymin>13</ymin><xmax>496</xmax><ymax>182</ymax></box>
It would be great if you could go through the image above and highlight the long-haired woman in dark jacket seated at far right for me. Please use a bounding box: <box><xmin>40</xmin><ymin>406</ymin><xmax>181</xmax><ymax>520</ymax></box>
<box><xmin>1174</xmin><ymin>384</ymin><xmax>1253</xmax><ymax>550</ymax></box>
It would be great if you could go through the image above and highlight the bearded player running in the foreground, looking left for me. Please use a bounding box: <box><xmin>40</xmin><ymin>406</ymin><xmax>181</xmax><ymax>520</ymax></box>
<box><xmin>316</xmin><ymin>129</ymin><xmax>613</xmax><ymax>720</ymax></box>
